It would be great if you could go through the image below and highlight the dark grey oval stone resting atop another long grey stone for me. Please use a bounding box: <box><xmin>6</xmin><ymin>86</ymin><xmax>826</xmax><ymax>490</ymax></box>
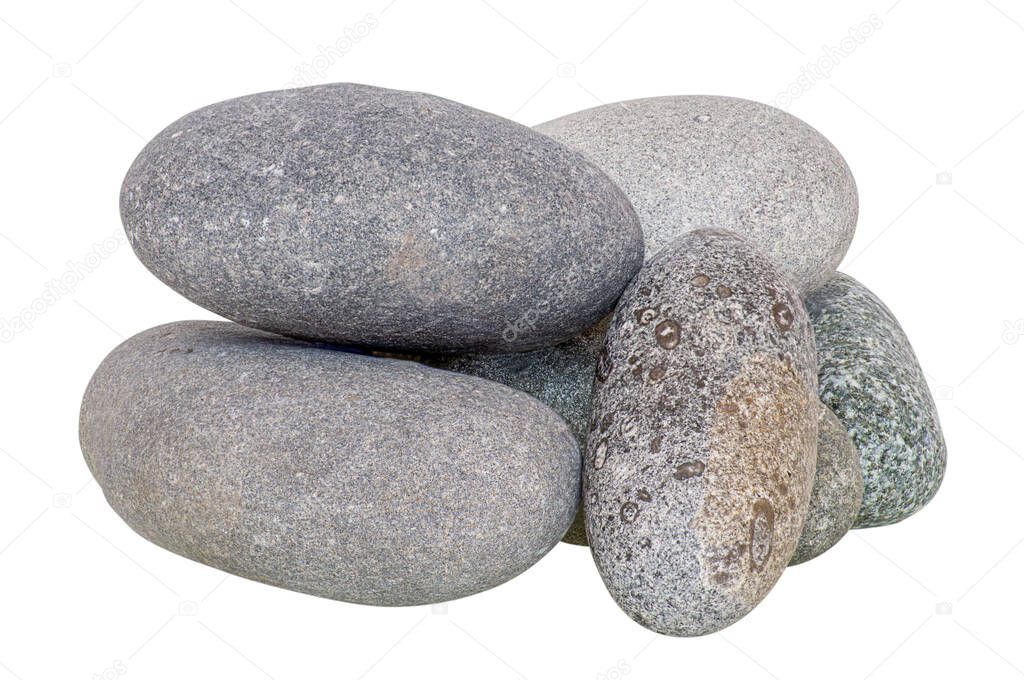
<box><xmin>121</xmin><ymin>84</ymin><xmax>642</xmax><ymax>352</ymax></box>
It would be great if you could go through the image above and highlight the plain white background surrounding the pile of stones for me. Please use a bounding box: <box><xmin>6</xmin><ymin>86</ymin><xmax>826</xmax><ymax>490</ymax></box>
<box><xmin>0</xmin><ymin>0</ymin><xmax>1024</xmax><ymax>680</ymax></box>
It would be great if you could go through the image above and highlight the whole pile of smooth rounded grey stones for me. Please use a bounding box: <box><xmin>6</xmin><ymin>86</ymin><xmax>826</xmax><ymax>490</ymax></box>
<box><xmin>80</xmin><ymin>84</ymin><xmax>945</xmax><ymax>636</ymax></box>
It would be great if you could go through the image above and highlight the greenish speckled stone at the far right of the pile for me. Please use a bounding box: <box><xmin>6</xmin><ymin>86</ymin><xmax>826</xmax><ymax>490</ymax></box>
<box><xmin>807</xmin><ymin>273</ymin><xmax>946</xmax><ymax>528</ymax></box>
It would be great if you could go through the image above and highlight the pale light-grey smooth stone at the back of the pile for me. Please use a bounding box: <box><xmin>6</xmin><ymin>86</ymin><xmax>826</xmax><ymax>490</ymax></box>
<box><xmin>535</xmin><ymin>95</ymin><xmax>857</xmax><ymax>292</ymax></box>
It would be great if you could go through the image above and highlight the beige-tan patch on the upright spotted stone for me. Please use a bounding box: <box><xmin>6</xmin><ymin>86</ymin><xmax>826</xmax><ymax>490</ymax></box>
<box><xmin>693</xmin><ymin>356</ymin><xmax>817</xmax><ymax>607</ymax></box>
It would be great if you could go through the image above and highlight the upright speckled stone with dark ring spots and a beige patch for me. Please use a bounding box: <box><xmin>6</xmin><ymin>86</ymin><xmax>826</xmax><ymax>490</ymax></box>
<box><xmin>584</xmin><ymin>229</ymin><xmax>818</xmax><ymax>635</ymax></box>
